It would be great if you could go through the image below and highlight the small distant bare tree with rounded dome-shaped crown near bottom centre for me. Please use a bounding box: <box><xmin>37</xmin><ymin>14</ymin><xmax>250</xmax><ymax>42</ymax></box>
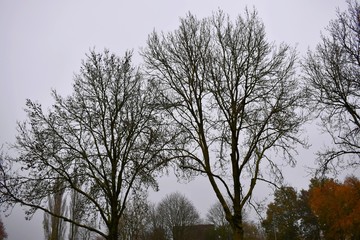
<box><xmin>156</xmin><ymin>192</ymin><xmax>200</xmax><ymax>240</ymax></box>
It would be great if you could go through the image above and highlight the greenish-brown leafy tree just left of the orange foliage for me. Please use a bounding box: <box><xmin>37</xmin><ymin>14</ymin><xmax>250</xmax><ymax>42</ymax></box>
<box><xmin>262</xmin><ymin>187</ymin><xmax>301</xmax><ymax>240</ymax></box>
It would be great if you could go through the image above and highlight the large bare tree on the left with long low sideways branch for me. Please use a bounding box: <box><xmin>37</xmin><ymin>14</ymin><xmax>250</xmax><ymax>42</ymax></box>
<box><xmin>0</xmin><ymin>51</ymin><xmax>171</xmax><ymax>240</ymax></box>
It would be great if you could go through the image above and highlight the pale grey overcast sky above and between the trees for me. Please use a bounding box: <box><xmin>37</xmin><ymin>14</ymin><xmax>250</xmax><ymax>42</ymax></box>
<box><xmin>0</xmin><ymin>0</ymin><xmax>352</xmax><ymax>240</ymax></box>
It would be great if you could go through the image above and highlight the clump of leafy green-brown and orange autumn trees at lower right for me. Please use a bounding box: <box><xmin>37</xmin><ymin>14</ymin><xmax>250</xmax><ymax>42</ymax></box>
<box><xmin>262</xmin><ymin>176</ymin><xmax>360</xmax><ymax>240</ymax></box>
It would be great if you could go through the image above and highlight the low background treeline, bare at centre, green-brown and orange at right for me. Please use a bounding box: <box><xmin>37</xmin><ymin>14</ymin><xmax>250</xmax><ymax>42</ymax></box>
<box><xmin>46</xmin><ymin>176</ymin><xmax>360</xmax><ymax>240</ymax></box>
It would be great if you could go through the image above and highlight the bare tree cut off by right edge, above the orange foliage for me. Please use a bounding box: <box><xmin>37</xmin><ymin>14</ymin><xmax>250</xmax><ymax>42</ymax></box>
<box><xmin>303</xmin><ymin>0</ymin><xmax>360</xmax><ymax>173</ymax></box>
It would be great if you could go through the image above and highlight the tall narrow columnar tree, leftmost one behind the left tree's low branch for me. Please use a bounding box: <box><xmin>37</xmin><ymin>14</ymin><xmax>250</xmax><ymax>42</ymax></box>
<box><xmin>43</xmin><ymin>180</ymin><xmax>66</xmax><ymax>240</ymax></box>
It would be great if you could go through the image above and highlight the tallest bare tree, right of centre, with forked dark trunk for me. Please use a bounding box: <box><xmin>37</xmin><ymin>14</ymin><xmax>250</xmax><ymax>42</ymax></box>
<box><xmin>142</xmin><ymin>8</ymin><xmax>305</xmax><ymax>240</ymax></box>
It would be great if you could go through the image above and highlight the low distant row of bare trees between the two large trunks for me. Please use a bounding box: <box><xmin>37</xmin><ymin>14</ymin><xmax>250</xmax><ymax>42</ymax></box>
<box><xmin>89</xmin><ymin>192</ymin><xmax>264</xmax><ymax>240</ymax></box>
